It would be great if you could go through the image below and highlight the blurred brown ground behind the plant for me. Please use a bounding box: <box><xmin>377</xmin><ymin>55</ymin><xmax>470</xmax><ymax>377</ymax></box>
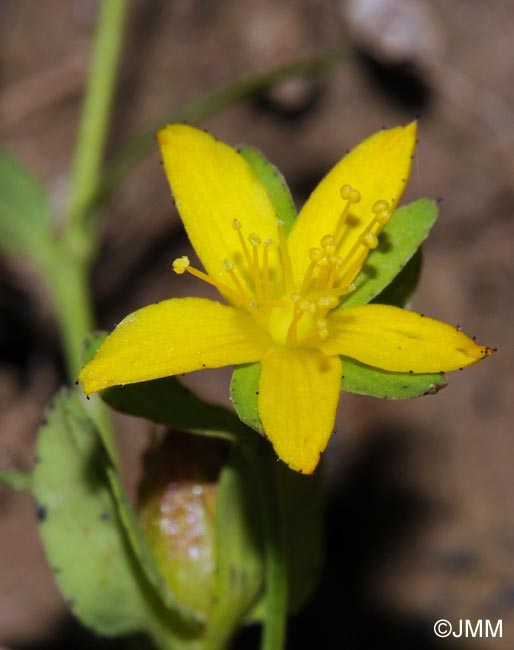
<box><xmin>0</xmin><ymin>0</ymin><xmax>514</xmax><ymax>650</ymax></box>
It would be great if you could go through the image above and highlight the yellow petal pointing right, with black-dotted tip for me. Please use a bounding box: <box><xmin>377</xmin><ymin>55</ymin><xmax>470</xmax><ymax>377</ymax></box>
<box><xmin>320</xmin><ymin>305</ymin><xmax>493</xmax><ymax>372</ymax></box>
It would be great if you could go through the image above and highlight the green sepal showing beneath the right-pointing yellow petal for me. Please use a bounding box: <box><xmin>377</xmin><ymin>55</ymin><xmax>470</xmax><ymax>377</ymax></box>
<box><xmin>341</xmin><ymin>357</ymin><xmax>448</xmax><ymax>399</ymax></box>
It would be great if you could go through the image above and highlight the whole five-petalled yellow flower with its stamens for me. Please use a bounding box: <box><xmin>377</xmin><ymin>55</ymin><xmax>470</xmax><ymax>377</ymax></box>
<box><xmin>79</xmin><ymin>123</ymin><xmax>492</xmax><ymax>473</ymax></box>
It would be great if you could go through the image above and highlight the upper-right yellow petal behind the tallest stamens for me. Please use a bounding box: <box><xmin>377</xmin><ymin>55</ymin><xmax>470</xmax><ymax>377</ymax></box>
<box><xmin>288</xmin><ymin>122</ymin><xmax>416</xmax><ymax>280</ymax></box>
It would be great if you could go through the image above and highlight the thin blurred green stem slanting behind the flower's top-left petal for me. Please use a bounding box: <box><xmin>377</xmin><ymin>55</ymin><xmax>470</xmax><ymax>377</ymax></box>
<box><xmin>92</xmin><ymin>52</ymin><xmax>342</xmax><ymax>207</ymax></box>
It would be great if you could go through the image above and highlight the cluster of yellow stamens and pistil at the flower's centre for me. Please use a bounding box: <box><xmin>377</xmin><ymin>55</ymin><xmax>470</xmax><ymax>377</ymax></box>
<box><xmin>173</xmin><ymin>185</ymin><xmax>392</xmax><ymax>346</ymax></box>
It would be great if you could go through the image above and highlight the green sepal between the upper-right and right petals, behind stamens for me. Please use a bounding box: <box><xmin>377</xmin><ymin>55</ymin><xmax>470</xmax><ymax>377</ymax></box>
<box><xmin>341</xmin><ymin>199</ymin><xmax>437</xmax><ymax>308</ymax></box>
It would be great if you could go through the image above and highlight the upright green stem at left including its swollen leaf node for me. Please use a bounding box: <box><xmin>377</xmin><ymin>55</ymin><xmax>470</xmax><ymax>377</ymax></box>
<box><xmin>48</xmin><ymin>0</ymin><xmax>129</xmax><ymax>379</ymax></box>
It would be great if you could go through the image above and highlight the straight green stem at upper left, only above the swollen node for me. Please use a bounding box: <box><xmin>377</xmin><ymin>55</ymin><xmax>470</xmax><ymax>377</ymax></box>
<box><xmin>69</xmin><ymin>0</ymin><xmax>129</xmax><ymax>232</ymax></box>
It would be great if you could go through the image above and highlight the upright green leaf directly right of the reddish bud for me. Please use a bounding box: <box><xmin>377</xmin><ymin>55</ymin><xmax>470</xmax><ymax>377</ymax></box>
<box><xmin>206</xmin><ymin>446</ymin><xmax>264</xmax><ymax>647</ymax></box>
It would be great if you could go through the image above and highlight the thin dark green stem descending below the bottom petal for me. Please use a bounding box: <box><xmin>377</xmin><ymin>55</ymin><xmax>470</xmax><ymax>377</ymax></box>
<box><xmin>261</xmin><ymin>441</ymin><xmax>289</xmax><ymax>650</ymax></box>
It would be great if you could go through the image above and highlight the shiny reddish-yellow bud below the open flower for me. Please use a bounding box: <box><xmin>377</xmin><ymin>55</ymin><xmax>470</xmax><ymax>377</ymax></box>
<box><xmin>138</xmin><ymin>431</ymin><xmax>225</xmax><ymax>617</ymax></box>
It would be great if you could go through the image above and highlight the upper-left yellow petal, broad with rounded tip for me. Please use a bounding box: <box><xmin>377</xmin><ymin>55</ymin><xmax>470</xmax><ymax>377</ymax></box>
<box><xmin>157</xmin><ymin>124</ymin><xmax>277</xmax><ymax>296</ymax></box>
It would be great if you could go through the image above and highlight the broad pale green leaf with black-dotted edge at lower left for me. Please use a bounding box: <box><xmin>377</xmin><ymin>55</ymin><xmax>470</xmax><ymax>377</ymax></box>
<box><xmin>33</xmin><ymin>390</ymin><xmax>197</xmax><ymax>649</ymax></box>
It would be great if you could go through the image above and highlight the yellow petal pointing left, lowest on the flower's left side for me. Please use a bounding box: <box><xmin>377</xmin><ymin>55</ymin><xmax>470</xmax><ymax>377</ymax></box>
<box><xmin>79</xmin><ymin>298</ymin><xmax>268</xmax><ymax>394</ymax></box>
